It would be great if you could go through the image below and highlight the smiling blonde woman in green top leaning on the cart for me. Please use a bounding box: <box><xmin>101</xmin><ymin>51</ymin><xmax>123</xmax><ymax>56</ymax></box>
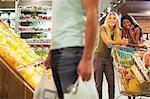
<box><xmin>94</xmin><ymin>12</ymin><xmax>127</xmax><ymax>99</ymax></box>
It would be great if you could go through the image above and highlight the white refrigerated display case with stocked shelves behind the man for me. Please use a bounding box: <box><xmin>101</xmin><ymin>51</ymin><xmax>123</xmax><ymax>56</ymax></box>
<box><xmin>16</xmin><ymin>0</ymin><xmax>52</xmax><ymax>58</ymax></box>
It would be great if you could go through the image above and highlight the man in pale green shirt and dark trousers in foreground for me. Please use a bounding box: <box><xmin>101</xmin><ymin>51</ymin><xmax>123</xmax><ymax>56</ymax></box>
<box><xmin>45</xmin><ymin>0</ymin><xmax>98</xmax><ymax>99</ymax></box>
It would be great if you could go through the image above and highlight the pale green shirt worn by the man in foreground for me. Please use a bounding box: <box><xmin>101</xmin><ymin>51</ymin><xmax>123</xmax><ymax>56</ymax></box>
<box><xmin>52</xmin><ymin>0</ymin><xmax>86</xmax><ymax>50</ymax></box>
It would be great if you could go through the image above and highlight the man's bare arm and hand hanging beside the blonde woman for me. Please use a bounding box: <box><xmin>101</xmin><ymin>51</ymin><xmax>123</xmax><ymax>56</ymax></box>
<box><xmin>78</xmin><ymin>0</ymin><xmax>98</xmax><ymax>80</ymax></box>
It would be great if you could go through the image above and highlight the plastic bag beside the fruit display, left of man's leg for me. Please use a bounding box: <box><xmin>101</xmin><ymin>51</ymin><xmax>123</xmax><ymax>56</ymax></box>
<box><xmin>33</xmin><ymin>72</ymin><xmax>59</xmax><ymax>99</ymax></box>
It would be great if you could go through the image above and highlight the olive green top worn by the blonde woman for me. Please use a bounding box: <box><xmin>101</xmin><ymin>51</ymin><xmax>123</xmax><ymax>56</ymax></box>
<box><xmin>95</xmin><ymin>26</ymin><xmax>111</xmax><ymax>59</ymax></box>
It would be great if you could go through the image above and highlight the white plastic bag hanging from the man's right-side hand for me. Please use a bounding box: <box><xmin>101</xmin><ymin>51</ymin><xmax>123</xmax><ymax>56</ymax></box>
<box><xmin>64</xmin><ymin>76</ymin><xmax>99</xmax><ymax>99</ymax></box>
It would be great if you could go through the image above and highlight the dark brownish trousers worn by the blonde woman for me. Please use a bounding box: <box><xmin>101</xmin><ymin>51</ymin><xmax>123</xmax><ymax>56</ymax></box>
<box><xmin>94</xmin><ymin>53</ymin><xmax>115</xmax><ymax>99</ymax></box>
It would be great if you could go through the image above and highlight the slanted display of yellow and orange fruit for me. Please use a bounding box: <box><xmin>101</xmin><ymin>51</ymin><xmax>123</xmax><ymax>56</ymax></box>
<box><xmin>0</xmin><ymin>21</ymin><xmax>52</xmax><ymax>88</ymax></box>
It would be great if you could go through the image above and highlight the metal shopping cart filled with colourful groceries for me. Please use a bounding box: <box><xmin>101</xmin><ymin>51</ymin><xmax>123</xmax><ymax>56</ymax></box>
<box><xmin>112</xmin><ymin>46</ymin><xmax>150</xmax><ymax>97</ymax></box>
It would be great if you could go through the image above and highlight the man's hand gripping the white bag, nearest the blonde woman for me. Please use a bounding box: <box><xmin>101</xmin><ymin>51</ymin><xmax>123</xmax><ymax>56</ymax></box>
<box><xmin>77</xmin><ymin>58</ymin><xmax>92</xmax><ymax>81</ymax></box>
